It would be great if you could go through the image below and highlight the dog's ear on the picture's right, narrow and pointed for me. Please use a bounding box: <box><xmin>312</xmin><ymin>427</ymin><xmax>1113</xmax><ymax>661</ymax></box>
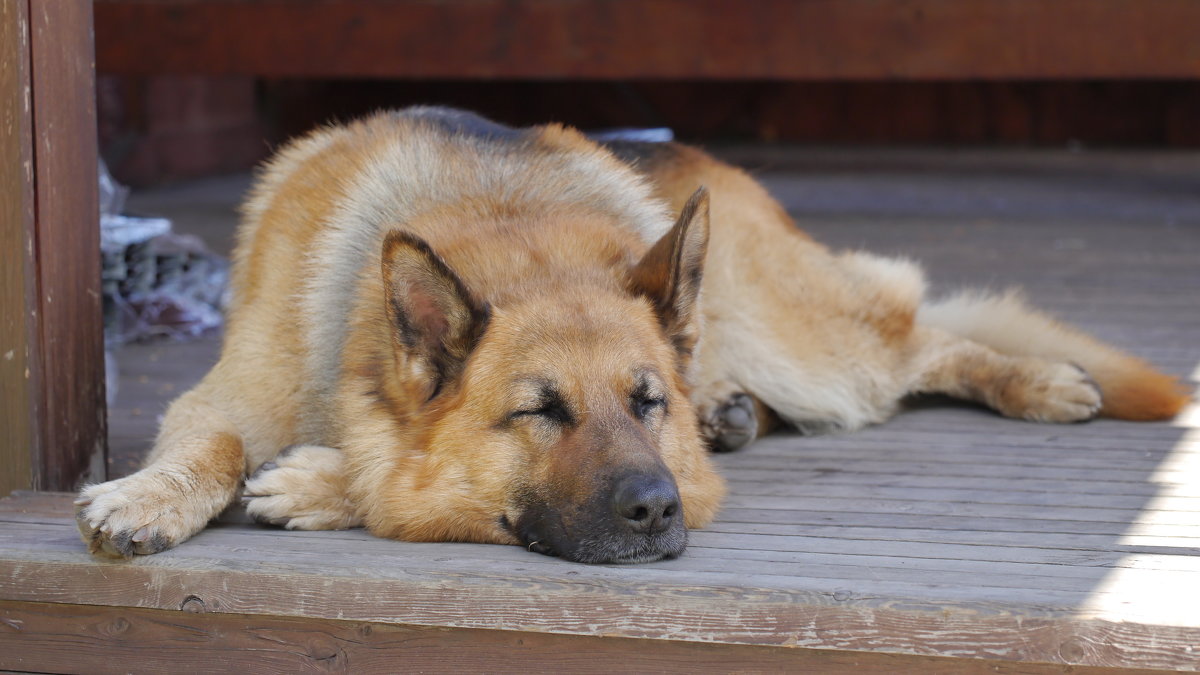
<box><xmin>631</xmin><ymin>187</ymin><xmax>708</xmax><ymax>357</ymax></box>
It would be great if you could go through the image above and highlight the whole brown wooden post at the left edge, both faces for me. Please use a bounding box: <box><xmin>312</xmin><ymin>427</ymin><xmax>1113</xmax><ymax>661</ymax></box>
<box><xmin>0</xmin><ymin>0</ymin><xmax>106</xmax><ymax>492</ymax></box>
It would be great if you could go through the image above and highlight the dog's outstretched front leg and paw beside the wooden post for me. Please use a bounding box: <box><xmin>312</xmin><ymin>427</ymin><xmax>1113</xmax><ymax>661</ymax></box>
<box><xmin>76</xmin><ymin>389</ymin><xmax>246</xmax><ymax>557</ymax></box>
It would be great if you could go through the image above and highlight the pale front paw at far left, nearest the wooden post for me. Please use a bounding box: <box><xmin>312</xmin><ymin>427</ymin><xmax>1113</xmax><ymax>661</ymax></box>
<box><xmin>74</xmin><ymin>470</ymin><xmax>209</xmax><ymax>557</ymax></box>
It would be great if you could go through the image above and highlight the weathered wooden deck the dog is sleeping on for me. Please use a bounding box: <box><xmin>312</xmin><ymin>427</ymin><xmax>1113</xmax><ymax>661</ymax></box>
<box><xmin>0</xmin><ymin>151</ymin><xmax>1200</xmax><ymax>673</ymax></box>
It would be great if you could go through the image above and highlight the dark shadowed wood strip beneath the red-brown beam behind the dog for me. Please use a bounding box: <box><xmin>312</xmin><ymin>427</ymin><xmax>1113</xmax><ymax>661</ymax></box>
<box><xmin>253</xmin><ymin>79</ymin><xmax>1200</xmax><ymax>148</ymax></box>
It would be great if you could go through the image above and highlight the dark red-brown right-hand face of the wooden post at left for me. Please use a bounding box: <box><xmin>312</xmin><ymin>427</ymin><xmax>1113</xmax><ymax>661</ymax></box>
<box><xmin>29</xmin><ymin>1</ymin><xmax>106</xmax><ymax>490</ymax></box>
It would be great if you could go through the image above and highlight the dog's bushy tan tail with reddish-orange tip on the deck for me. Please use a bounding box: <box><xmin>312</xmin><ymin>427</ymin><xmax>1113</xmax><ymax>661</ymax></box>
<box><xmin>918</xmin><ymin>291</ymin><xmax>1190</xmax><ymax>420</ymax></box>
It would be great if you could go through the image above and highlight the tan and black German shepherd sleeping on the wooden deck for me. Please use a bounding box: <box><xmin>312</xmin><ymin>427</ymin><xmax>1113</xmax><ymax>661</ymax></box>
<box><xmin>76</xmin><ymin>108</ymin><xmax>1188</xmax><ymax>562</ymax></box>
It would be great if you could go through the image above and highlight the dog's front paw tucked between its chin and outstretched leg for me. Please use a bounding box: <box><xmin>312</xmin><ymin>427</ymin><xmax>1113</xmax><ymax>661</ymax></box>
<box><xmin>241</xmin><ymin>446</ymin><xmax>361</xmax><ymax>530</ymax></box>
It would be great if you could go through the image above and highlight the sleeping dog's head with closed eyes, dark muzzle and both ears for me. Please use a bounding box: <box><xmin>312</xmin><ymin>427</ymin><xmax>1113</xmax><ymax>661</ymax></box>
<box><xmin>366</xmin><ymin>191</ymin><xmax>724</xmax><ymax>562</ymax></box>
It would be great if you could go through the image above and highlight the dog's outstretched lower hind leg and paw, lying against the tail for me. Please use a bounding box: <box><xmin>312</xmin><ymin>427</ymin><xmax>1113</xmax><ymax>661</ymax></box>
<box><xmin>910</xmin><ymin>327</ymin><xmax>1102</xmax><ymax>423</ymax></box>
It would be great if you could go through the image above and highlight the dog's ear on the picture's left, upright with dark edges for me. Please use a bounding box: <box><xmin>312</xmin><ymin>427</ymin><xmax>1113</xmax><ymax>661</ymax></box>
<box><xmin>383</xmin><ymin>229</ymin><xmax>488</xmax><ymax>399</ymax></box>
